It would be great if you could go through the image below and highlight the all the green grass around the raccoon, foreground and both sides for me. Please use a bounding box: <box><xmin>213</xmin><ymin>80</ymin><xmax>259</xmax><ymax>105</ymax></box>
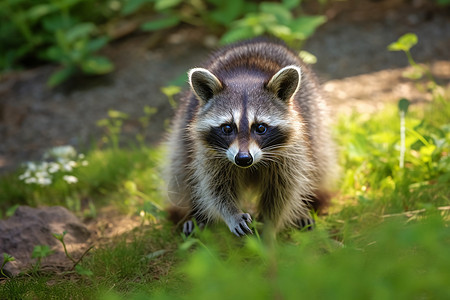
<box><xmin>0</xmin><ymin>88</ymin><xmax>450</xmax><ymax>299</ymax></box>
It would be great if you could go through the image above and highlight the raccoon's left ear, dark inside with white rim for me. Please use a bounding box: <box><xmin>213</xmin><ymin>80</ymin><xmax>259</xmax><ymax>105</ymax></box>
<box><xmin>188</xmin><ymin>68</ymin><xmax>222</xmax><ymax>104</ymax></box>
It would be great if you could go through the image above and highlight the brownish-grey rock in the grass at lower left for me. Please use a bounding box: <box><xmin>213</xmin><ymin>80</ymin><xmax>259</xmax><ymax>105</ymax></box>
<box><xmin>0</xmin><ymin>206</ymin><xmax>91</xmax><ymax>276</ymax></box>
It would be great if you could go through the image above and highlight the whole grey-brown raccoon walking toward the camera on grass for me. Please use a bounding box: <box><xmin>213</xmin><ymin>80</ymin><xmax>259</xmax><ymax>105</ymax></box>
<box><xmin>167</xmin><ymin>38</ymin><xmax>336</xmax><ymax>236</ymax></box>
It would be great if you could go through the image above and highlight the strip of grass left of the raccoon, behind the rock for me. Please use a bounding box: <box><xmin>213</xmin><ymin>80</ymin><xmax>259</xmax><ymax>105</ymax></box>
<box><xmin>0</xmin><ymin>148</ymin><xmax>164</xmax><ymax>219</ymax></box>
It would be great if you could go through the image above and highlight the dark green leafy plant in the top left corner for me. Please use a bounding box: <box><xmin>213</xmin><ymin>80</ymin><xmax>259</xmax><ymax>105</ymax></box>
<box><xmin>0</xmin><ymin>0</ymin><xmax>113</xmax><ymax>86</ymax></box>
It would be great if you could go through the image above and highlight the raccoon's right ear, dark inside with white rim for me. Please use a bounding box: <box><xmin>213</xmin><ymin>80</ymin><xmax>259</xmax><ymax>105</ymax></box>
<box><xmin>266</xmin><ymin>66</ymin><xmax>302</xmax><ymax>102</ymax></box>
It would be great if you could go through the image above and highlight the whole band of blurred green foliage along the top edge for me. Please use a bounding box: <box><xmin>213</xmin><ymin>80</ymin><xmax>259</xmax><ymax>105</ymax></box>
<box><xmin>0</xmin><ymin>0</ymin><xmax>325</xmax><ymax>87</ymax></box>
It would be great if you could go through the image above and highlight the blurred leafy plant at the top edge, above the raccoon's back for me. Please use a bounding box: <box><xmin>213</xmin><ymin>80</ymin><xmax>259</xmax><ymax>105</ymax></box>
<box><xmin>122</xmin><ymin>0</ymin><xmax>326</xmax><ymax>44</ymax></box>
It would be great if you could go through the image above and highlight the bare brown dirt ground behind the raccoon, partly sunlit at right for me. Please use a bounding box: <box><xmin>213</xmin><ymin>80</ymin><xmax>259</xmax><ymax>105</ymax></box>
<box><xmin>0</xmin><ymin>0</ymin><xmax>450</xmax><ymax>174</ymax></box>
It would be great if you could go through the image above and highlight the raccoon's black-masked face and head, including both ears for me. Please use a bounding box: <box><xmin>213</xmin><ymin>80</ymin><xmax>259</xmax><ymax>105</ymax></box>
<box><xmin>189</xmin><ymin>66</ymin><xmax>300</xmax><ymax>168</ymax></box>
